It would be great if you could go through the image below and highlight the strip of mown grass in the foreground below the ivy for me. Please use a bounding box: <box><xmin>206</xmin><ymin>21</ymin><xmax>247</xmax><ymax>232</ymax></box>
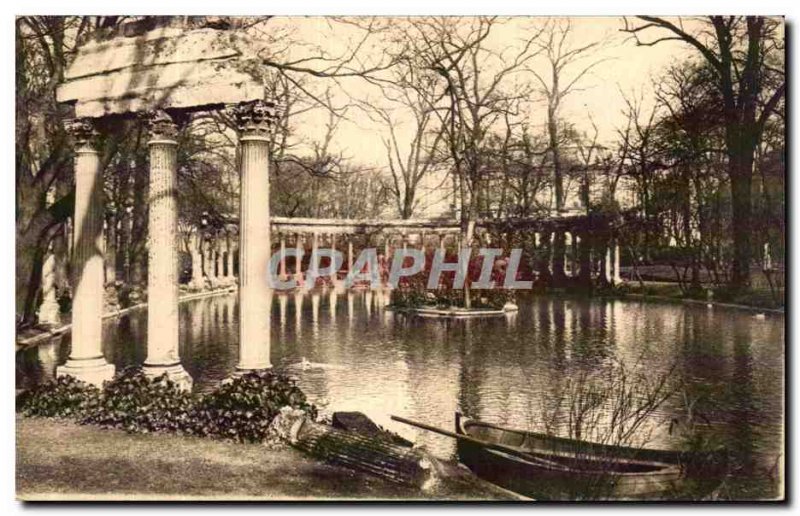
<box><xmin>16</xmin><ymin>415</ymin><xmax>509</xmax><ymax>500</ymax></box>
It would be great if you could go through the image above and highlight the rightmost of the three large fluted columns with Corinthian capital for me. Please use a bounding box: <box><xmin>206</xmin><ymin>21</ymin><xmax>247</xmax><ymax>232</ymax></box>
<box><xmin>235</xmin><ymin>100</ymin><xmax>275</xmax><ymax>371</ymax></box>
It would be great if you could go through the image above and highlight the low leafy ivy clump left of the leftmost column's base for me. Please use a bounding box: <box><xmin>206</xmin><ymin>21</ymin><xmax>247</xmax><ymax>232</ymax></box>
<box><xmin>17</xmin><ymin>376</ymin><xmax>100</xmax><ymax>418</ymax></box>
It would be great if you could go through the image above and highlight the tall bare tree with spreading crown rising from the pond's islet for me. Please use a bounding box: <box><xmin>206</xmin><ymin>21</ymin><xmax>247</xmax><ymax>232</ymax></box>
<box><xmin>400</xmin><ymin>17</ymin><xmax>539</xmax><ymax>307</ymax></box>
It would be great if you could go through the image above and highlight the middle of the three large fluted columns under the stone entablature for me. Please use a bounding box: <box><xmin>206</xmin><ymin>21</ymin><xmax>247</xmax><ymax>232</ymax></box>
<box><xmin>144</xmin><ymin>111</ymin><xmax>192</xmax><ymax>389</ymax></box>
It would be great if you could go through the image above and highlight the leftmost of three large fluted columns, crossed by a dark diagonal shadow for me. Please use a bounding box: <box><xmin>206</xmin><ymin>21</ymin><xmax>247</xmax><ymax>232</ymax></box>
<box><xmin>56</xmin><ymin>119</ymin><xmax>114</xmax><ymax>386</ymax></box>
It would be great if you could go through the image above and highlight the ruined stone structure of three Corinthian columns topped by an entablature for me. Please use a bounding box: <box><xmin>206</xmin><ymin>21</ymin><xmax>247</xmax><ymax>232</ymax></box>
<box><xmin>57</xmin><ymin>17</ymin><xmax>276</xmax><ymax>388</ymax></box>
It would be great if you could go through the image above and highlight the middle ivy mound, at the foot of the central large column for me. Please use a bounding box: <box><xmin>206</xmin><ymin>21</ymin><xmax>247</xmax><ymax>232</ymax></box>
<box><xmin>81</xmin><ymin>368</ymin><xmax>194</xmax><ymax>433</ymax></box>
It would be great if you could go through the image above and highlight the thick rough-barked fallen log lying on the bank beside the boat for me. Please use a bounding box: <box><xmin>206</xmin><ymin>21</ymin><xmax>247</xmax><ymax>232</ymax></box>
<box><xmin>272</xmin><ymin>409</ymin><xmax>435</xmax><ymax>488</ymax></box>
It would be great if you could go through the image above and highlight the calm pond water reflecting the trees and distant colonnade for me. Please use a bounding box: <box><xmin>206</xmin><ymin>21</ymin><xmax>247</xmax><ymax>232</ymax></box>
<box><xmin>16</xmin><ymin>290</ymin><xmax>785</xmax><ymax>499</ymax></box>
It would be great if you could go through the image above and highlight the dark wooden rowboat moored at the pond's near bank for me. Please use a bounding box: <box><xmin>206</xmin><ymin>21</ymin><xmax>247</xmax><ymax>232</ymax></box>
<box><xmin>455</xmin><ymin>413</ymin><xmax>726</xmax><ymax>500</ymax></box>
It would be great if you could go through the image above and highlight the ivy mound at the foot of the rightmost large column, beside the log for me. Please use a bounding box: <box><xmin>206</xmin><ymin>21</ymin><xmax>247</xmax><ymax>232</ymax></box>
<box><xmin>191</xmin><ymin>372</ymin><xmax>317</xmax><ymax>442</ymax></box>
